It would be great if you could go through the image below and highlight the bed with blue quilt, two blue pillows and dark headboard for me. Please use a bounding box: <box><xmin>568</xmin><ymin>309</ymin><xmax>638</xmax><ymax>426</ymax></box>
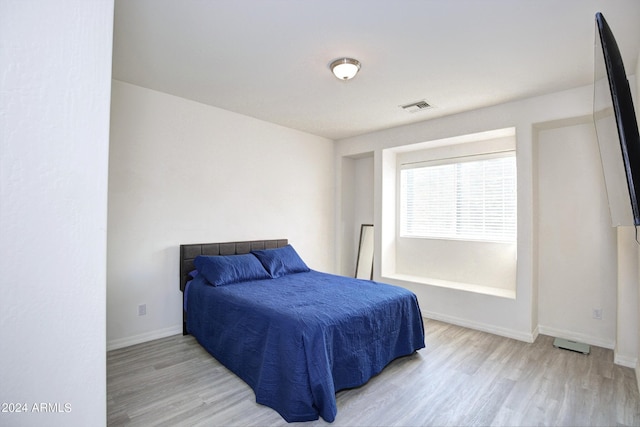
<box><xmin>180</xmin><ymin>239</ymin><xmax>424</xmax><ymax>422</ymax></box>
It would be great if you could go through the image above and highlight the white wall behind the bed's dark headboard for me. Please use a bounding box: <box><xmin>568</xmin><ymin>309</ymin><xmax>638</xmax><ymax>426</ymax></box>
<box><xmin>107</xmin><ymin>81</ymin><xmax>335</xmax><ymax>348</ymax></box>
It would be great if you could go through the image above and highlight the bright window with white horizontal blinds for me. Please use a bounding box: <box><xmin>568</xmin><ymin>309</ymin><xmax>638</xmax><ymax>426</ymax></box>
<box><xmin>400</xmin><ymin>151</ymin><xmax>517</xmax><ymax>242</ymax></box>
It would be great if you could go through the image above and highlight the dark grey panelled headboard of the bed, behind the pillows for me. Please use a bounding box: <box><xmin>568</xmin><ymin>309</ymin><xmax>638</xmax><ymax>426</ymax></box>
<box><xmin>180</xmin><ymin>239</ymin><xmax>289</xmax><ymax>335</ymax></box>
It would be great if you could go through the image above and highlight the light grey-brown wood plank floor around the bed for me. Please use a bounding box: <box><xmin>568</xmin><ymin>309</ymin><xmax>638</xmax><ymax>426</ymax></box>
<box><xmin>107</xmin><ymin>320</ymin><xmax>640</xmax><ymax>427</ymax></box>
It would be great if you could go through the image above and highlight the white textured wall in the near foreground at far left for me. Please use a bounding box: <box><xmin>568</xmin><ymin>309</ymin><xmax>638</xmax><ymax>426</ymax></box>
<box><xmin>0</xmin><ymin>0</ymin><xmax>113</xmax><ymax>426</ymax></box>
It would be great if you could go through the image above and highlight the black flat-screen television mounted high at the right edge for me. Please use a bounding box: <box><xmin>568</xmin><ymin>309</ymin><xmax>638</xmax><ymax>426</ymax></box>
<box><xmin>594</xmin><ymin>12</ymin><xmax>640</xmax><ymax>226</ymax></box>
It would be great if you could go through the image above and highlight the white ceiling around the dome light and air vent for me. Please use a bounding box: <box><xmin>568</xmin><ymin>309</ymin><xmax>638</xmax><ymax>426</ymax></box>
<box><xmin>113</xmin><ymin>0</ymin><xmax>640</xmax><ymax>140</ymax></box>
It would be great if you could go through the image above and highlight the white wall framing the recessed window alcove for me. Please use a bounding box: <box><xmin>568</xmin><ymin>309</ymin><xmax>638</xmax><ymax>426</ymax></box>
<box><xmin>336</xmin><ymin>86</ymin><xmax>615</xmax><ymax>340</ymax></box>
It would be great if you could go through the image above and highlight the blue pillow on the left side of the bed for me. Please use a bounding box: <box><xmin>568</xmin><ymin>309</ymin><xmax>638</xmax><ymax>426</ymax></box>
<box><xmin>193</xmin><ymin>254</ymin><xmax>270</xmax><ymax>286</ymax></box>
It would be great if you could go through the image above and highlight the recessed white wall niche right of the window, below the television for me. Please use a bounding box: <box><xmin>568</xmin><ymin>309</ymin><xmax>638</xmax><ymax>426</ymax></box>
<box><xmin>536</xmin><ymin>117</ymin><xmax>618</xmax><ymax>348</ymax></box>
